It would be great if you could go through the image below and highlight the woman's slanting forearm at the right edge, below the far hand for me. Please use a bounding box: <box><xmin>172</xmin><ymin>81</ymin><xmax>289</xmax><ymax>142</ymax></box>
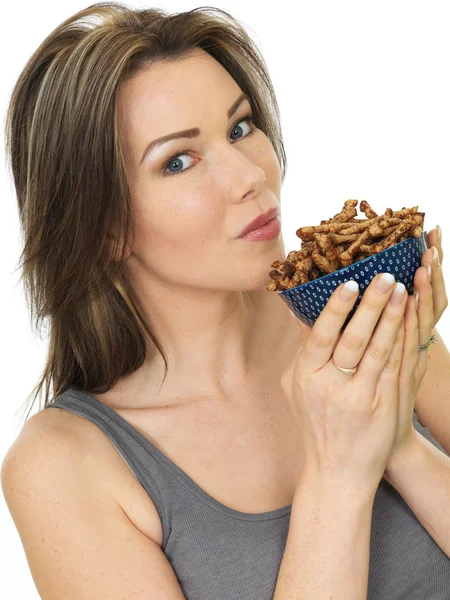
<box><xmin>384</xmin><ymin>431</ymin><xmax>450</xmax><ymax>558</ymax></box>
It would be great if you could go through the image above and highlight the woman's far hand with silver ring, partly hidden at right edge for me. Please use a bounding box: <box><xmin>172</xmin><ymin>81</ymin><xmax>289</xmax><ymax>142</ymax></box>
<box><xmin>386</xmin><ymin>229</ymin><xmax>448</xmax><ymax>470</ymax></box>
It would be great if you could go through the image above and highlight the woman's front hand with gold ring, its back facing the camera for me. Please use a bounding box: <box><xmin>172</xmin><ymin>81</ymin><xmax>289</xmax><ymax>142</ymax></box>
<box><xmin>281</xmin><ymin>274</ymin><xmax>408</xmax><ymax>490</ymax></box>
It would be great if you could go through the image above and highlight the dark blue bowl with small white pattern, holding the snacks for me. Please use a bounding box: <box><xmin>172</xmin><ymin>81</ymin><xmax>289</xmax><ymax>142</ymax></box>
<box><xmin>278</xmin><ymin>232</ymin><xmax>427</xmax><ymax>332</ymax></box>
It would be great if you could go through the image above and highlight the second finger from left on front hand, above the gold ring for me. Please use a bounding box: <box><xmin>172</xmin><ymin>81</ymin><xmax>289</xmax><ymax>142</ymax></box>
<box><xmin>333</xmin><ymin>274</ymin><xmax>405</xmax><ymax>376</ymax></box>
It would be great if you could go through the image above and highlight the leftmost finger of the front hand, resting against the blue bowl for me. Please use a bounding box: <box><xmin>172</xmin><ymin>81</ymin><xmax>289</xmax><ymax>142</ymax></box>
<box><xmin>302</xmin><ymin>281</ymin><xmax>359</xmax><ymax>374</ymax></box>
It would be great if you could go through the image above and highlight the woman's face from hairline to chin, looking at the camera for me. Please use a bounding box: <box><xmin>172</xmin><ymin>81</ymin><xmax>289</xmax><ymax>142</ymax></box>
<box><xmin>120</xmin><ymin>49</ymin><xmax>285</xmax><ymax>291</ymax></box>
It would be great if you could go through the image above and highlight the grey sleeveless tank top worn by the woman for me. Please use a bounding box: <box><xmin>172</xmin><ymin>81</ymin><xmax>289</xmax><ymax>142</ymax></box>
<box><xmin>46</xmin><ymin>388</ymin><xmax>450</xmax><ymax>600</ymax></box>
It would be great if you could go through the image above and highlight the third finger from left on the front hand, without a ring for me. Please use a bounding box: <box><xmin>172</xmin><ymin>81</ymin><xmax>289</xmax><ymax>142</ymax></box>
<box><xmin>350</xmin><ymin>283</ymin><xmax>408</xmax><ymax>391</ymax></box>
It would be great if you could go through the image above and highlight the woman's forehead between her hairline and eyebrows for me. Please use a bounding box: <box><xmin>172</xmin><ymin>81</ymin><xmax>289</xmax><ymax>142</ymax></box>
<box><xmin>119</xmin><ymin>49</ymin><xmax>240</xmax><ymax>159</ymax></box>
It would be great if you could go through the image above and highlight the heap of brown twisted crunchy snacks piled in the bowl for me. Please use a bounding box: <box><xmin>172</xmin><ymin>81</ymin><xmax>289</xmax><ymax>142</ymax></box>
<box><xmin>267</xmin><ymin>200</ymin><xmax>425</xmax><ymax>292</ymax></box>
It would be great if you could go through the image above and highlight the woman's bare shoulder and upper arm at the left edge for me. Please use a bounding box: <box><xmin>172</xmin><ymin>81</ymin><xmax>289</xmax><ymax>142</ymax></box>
<box><xmin>1</xmin><ymin>408</ymin><xmax>184</xmax><ymax>600</ymax></box>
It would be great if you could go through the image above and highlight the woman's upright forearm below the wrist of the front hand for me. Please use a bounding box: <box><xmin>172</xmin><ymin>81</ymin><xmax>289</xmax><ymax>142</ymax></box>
<box><xmin>273</xmin><ymin>475</ymin><xmax>376</xmax><ymax>600</ymax></box>
